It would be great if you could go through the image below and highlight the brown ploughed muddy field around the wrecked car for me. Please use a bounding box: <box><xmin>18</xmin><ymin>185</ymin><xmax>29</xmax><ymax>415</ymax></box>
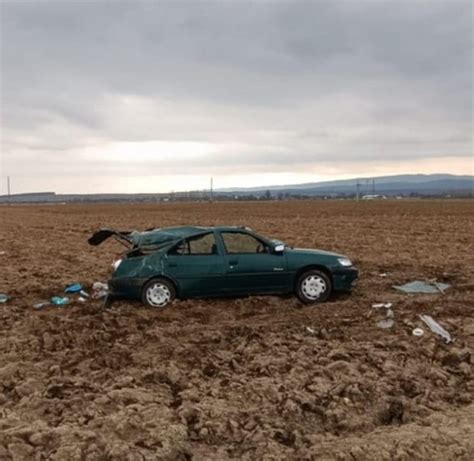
<box><xmin>0</xmin><ymin>201</ymin><xmax>474</xmax><ymax>461</ymax></box>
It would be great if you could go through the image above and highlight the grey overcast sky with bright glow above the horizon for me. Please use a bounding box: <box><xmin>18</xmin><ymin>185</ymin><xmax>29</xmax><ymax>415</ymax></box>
<box><xmin>0</xmin><ymin>0</ymin><xmax>473</xmax><ymax>193</ymax></box>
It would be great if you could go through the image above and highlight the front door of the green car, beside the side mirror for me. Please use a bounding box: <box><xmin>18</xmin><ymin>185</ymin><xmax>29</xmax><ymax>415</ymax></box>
<box><xmin>219</xmin><ymin>230</ymin><xmax>290</xmax><ymax>294</ymax></box>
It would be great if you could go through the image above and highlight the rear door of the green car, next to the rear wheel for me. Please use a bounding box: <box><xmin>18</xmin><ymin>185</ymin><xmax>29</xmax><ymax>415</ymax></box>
<box><xmin>164</xmin><ymin>232</ymin><xmax>225</xmax><ymax>296</ymax></box>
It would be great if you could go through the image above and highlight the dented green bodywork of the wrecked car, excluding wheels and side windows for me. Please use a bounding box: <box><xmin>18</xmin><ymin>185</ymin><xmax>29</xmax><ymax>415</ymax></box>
<box><xmin>89</xmin><ymin>226</ymin><xmax>358</xmax><ymax>298</ymax></box>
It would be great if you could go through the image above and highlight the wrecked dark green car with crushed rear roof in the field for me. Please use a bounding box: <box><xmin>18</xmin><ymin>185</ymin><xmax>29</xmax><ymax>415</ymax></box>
<box><xmin>89</xmin><ymin>227</ymin><xmax>358</xmax><ymax>307</ymax></box>
